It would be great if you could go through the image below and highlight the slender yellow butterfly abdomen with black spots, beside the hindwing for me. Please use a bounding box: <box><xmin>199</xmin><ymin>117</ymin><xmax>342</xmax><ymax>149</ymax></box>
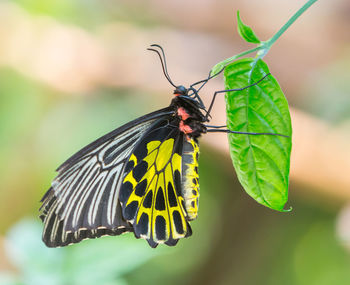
<box><xmin>182</xmin><ymin>139</ymin><xmax>199</xmax><ymax>220</ymax></box>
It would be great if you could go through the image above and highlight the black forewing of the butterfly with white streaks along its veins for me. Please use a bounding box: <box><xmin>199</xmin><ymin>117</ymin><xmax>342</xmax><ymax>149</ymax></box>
<box><xmin>40</xmin><ymin>108</ymin><xmax>173</xmax><ymax>247</ymax></box>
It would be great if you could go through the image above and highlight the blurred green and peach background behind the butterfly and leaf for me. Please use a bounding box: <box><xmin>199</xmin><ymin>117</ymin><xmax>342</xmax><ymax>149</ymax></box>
<box><xmin>0</xmin><ymin>0</ymin><xmax>350</xmax><ymax>285</ymax></box>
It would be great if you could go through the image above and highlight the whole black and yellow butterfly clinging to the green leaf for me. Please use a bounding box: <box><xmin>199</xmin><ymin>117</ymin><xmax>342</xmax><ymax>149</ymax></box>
<box><xmin>40</xmin><ymin>44</ymin><xmax>280</xmax><ymax>248</ymax></box>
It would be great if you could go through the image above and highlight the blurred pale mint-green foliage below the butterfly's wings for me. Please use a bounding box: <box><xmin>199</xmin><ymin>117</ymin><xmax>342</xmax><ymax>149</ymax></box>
<box><xmin>1</xmin><ymin>220</ymin><xmax>162</xmax><ymax>285</ymax></box>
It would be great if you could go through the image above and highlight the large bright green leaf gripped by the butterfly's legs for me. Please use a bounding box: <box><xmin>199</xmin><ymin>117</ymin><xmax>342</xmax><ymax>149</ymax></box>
<box><xmin>224</xmin><ymin>58</ymin><xmax>292</xmax><ymax>211</ymax></box>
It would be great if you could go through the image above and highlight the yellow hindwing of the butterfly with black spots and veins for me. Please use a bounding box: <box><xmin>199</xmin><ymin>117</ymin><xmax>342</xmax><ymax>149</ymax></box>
<box><xmin>119</xmin><ymin>115</ymin><xmax>192</xmax><ymax>247</ymax></box>
